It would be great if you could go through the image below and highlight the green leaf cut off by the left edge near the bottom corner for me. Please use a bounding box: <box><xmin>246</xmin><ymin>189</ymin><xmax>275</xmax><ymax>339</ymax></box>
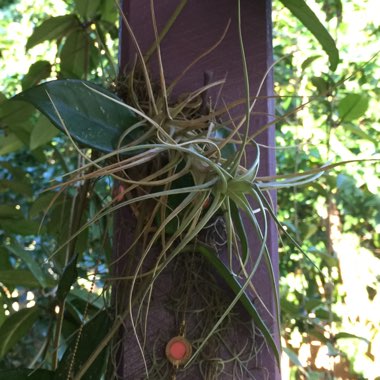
<box><xmin>0</xmin><ymin>307</ymin><xmax>39</xmax><ymax>358</ymax></box>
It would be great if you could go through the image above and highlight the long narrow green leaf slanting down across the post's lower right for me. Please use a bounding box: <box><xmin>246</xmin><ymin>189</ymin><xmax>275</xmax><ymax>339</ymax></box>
<box><xmin>197</xmin><ymin>244</ymin><xmax>280</xmax><ymax>365</ymax></box>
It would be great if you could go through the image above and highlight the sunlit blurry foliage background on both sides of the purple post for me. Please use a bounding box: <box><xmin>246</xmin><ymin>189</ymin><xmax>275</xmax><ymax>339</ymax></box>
<box><xmin>0</xmin><ymin>0</ymin><xmax>380</xmax><ymax>379</ymax></box>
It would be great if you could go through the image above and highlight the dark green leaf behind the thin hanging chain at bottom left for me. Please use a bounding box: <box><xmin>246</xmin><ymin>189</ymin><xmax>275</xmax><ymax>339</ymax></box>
<box><xmin>55</xmin><ymin>310</ymin><xmax>111</xmax><ymax>380</ymax></box>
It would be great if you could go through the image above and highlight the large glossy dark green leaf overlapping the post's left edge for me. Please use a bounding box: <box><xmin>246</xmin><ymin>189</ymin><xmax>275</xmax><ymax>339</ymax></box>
<box><xmin>14</xmin><ymin>79</ymin><xmax>141</xmax><ymax>152</ymax></box>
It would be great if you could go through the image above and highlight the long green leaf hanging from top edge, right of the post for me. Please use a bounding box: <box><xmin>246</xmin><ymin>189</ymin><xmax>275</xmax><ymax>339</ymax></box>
<box><xmin>280</xmin><ymin>0</ymin><xmax>339</xmax><ymax>70</ymax></box>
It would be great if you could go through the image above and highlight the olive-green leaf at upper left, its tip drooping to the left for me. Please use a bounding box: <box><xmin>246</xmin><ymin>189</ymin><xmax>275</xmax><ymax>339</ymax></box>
<box><xmin>26</xmin><ymin>14</ymin><xmax>80</xmax><ymax>50</ymax></box>
